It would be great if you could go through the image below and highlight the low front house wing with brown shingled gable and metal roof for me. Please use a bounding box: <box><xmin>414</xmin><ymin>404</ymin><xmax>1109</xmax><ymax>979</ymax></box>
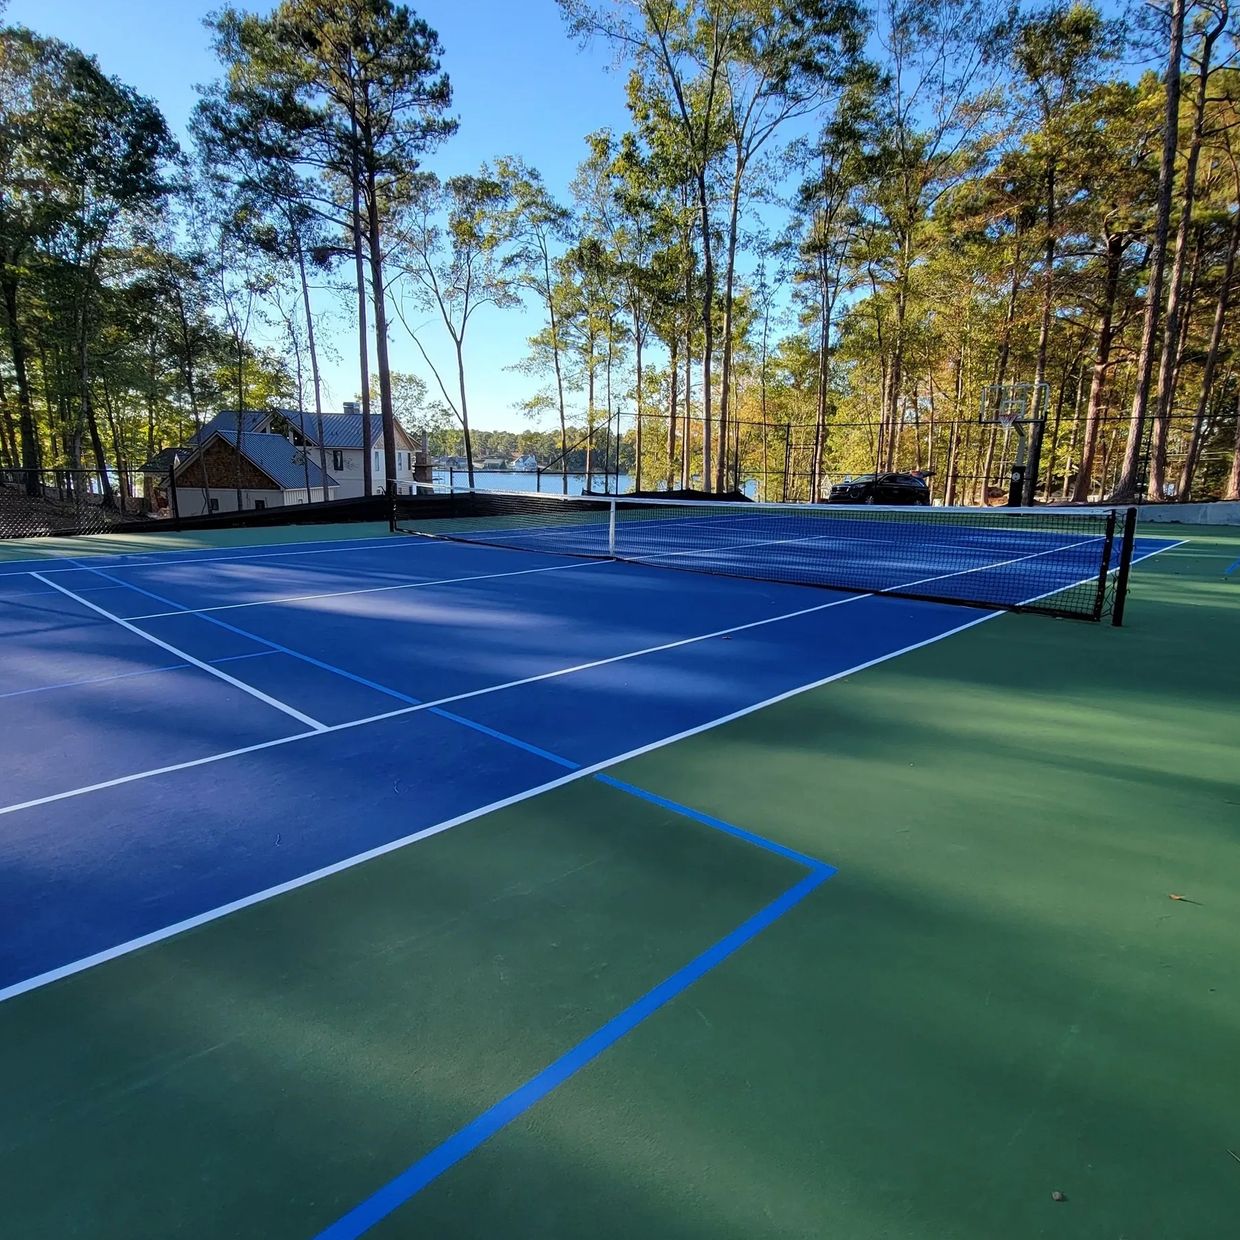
<box><xmin>169</xmin><ymin>423</ymin><xmax>341</xmax><ymax>517</ymax></box>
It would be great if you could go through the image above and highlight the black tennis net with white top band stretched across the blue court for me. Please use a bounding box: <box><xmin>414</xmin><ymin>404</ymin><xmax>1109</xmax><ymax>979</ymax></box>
<box><xmin>396</xmin><ymin>485</ymin><xmax>1132</xmax><ymax>620</ymax></box>
